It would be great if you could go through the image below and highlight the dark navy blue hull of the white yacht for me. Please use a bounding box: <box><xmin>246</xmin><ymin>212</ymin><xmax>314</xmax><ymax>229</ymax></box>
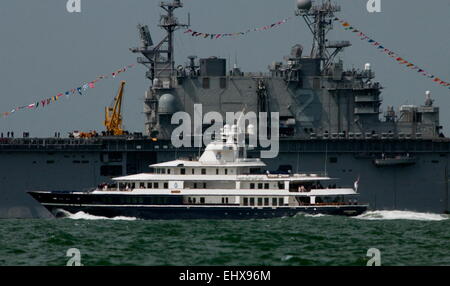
<box><xmin>29</xmin><ymin>192</ymin><xmax>367</xmax><ymax>219</ymax></box>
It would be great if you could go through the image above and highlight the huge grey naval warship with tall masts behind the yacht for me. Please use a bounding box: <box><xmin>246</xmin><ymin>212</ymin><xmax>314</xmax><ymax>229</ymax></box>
<box><xmin>0</xmin><ymin>0</ymin><xmax>450</xmax><ymax>217</ymax></box>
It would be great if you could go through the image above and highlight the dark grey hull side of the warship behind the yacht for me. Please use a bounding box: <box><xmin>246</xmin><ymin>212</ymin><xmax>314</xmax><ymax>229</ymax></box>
<box><xmin>0</xmin><ymin>138</ymin><xmax>450</xmax><ymax>218</ymax></box>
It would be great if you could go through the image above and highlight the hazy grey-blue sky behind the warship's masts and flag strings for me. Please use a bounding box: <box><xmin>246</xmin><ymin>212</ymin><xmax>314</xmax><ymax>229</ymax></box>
<box><xmin>0</xmin><ymin>0</ymin><xmax>450</xmax><ymax>136</ymax></box>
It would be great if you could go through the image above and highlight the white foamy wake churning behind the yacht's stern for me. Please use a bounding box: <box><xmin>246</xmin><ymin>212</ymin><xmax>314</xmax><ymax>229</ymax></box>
<box><xmin>354</xmin><ymin>211</ymin><xmax>449</xmax><ymax>221</ymax></box>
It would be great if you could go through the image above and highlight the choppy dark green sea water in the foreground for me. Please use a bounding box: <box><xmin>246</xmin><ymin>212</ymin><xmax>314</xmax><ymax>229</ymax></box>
<box><xmin>0</xmin><ymin>211</ymin><xmax>450</xmax><ymax>265</ymax></box>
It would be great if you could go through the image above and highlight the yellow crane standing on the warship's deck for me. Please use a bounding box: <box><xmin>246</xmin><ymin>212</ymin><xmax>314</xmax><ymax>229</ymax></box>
<box><xmin>104</xmin><ymin>81</ymin><xmax>125</xmax><ymax>135</ymax></box>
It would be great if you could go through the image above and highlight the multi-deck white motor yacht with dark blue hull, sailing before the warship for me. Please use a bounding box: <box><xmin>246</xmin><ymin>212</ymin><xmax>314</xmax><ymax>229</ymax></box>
<box><xmin>29</xmin><ymin>126</ymin><xmax>368</xmax><ymax>219</ymax></box>
